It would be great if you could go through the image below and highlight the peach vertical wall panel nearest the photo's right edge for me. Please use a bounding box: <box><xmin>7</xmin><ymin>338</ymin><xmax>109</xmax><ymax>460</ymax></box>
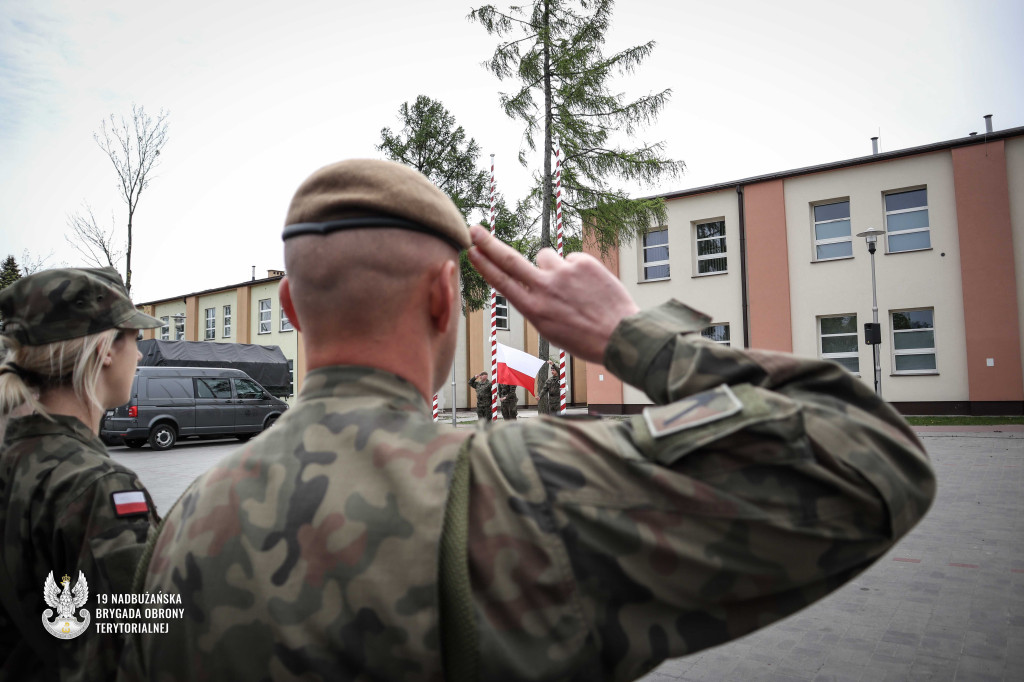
<box><xmin>952</xmin><ymin>140</ymin><xmax>1024</xmax><ymax>400</ymax></box>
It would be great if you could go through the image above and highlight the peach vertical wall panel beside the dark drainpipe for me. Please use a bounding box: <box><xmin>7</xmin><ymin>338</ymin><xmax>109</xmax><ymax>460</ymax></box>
<box><xmin>743</xmin><ymin>180</ymin><xmax>793</xmax><ymax>352</ymax></box>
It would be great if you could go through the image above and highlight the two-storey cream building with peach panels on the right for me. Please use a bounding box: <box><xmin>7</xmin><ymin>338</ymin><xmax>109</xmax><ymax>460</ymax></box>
<box><xmin>587</xmin><ymin>118</ymin><xmax>1024</xmax><ymax>415</ymax></box>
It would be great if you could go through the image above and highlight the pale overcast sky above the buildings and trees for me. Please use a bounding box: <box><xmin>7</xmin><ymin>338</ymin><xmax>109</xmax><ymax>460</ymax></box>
<box><xmin>0</xmin><ymin>0</ymin><xmax>1024</xmax><ymax>302</ymax></box>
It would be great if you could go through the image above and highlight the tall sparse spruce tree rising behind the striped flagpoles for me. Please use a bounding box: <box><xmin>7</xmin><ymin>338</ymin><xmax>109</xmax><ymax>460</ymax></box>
<box><xmin>469</xmin><ymin>0</ymin><xmax>685</xmax><ymax>357</ymax></box>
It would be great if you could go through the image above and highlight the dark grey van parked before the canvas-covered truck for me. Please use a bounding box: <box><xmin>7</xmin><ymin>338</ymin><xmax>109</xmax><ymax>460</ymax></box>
<box><xmin>99</xmin><ymin>367</ymin><xmax>288</xmax><ymax>450</ymax></box>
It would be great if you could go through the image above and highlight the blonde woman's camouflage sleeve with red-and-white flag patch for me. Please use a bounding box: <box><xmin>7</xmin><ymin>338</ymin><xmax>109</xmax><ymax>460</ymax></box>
<box><xmin>49</xmin><ymin>472</ymin><xmax>158</xmax><ymax>680</ymax></box>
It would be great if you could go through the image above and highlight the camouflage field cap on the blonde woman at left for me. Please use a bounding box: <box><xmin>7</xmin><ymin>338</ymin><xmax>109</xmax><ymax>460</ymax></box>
<box><xmin>0</xmin><ymin>267</ymin><xmax>164</xmax><ymax>346</ymax></box>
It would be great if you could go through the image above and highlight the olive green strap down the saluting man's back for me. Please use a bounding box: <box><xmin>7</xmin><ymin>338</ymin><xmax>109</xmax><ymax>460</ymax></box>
<box><xmin>439</xmin><ymin>438</ymin><xmax>479</xmax><ymax>682</ymax></box>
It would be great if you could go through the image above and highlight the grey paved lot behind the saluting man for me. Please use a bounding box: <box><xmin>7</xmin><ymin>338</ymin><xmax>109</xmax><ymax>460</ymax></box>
<box><xmin>112</xmin><ymin>424</ymin><xmax>1024</xmax><ymax>682</ymax></box>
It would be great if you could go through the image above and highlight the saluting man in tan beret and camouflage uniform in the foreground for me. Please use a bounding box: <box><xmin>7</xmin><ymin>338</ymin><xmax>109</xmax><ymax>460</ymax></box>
<box><xmin>126</xmin><ymin>161</ymin><xmax>935</xmax><ymax>682</ymax></box>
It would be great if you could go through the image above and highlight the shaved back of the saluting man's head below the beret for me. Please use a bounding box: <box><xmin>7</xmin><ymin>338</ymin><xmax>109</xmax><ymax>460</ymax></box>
<box><xmin>285</xmin><ymin>227</ymin><xmax>458</xmax><ymax>341</ymax></box>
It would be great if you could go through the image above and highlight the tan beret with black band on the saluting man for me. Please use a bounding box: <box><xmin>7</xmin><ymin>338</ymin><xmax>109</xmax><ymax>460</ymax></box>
<box><xmin>282</xmin><ymin>159</ymin><xmax>470</xmax><ymax>250</ymax></box>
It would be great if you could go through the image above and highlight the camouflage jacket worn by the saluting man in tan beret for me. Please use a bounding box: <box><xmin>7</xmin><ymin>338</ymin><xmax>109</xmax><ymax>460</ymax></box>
<box><xmin>130</xmin><ymin>302</ymin><xmax>935</xmax><ymax>681</ymax></box>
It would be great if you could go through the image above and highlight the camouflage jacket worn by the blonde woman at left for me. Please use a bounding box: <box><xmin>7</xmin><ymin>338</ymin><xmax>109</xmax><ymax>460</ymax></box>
<box><xmin>0</xmin><ymin>415</ymin><xmax>159</xmax><ymax>680</ymax></box>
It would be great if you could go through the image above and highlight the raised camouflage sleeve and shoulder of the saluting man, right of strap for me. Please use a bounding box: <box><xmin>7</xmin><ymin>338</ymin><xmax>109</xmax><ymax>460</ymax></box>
<box><xmin>469</xmin><ymin>303</ymin><xmax>935</xmax><ymax>680</ymax></box>
